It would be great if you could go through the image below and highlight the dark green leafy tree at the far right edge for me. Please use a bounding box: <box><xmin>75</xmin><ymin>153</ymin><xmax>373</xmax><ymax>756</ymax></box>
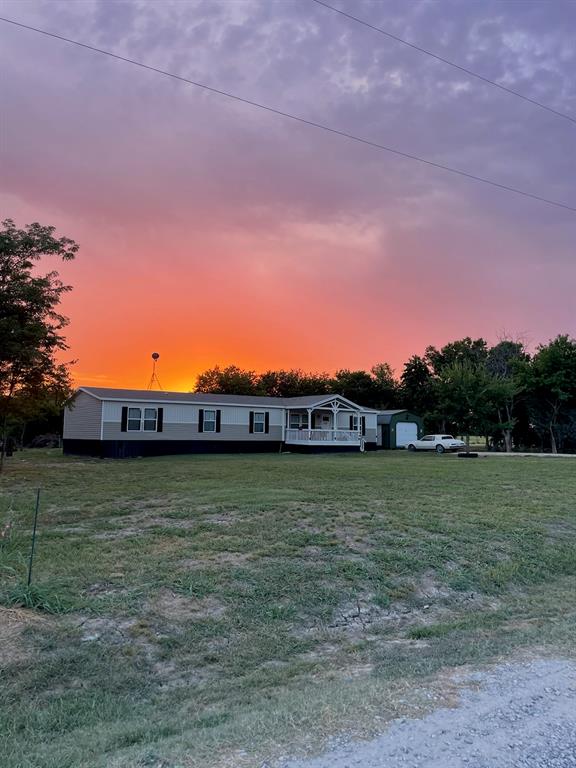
<box><xmin>525</xmin><ymin>335</ymin><xmax>576</xmax><ymax>453</ymax></box>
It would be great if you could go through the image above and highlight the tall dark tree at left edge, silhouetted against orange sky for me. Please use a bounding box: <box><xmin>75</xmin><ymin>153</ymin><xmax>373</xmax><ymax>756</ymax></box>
<box><xmin>0</xmin><ymin>219</ymin><xmax>78</xmax><ymax>470</ymax></box>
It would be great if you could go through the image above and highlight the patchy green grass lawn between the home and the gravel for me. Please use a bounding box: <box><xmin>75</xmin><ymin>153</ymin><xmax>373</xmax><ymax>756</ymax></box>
<box><xmin>0</xmin><ymin>451</ymin><xmax>576</xmax><ymax>768</ymax></box>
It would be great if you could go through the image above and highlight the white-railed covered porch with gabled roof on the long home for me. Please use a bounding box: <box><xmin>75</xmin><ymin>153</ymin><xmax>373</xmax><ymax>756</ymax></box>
<box><xmin>284</xmin><ymin>398</ymin><xmax>366</xmax><ymax>448</ymax></box>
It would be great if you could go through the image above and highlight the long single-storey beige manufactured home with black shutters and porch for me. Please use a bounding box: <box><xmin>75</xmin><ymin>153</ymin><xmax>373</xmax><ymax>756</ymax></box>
<box><xmin>63</xmin><ymin>387</ymin><xmax>378</xmax><ymax>458</ymax></box>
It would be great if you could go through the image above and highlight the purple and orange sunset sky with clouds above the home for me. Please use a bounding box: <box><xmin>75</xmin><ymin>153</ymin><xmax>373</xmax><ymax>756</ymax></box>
<box><xmin>0</xmin><ymin>0</ymin><xmax>576</xmax><ymax>390</ymax></box>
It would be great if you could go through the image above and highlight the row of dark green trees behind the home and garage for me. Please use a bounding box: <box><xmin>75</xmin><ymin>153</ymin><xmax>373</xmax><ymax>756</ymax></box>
<box><xmin>195</xmin><ymin>335</ymin><xmax>576</xmax><ymax>453</ymax></box>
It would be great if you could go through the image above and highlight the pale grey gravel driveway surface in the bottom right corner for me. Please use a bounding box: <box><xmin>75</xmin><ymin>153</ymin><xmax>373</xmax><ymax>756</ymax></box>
<box><xmin>282</xmin><ymin>660</ymin><xmax>576</xmax><ymax>768</ymax></box>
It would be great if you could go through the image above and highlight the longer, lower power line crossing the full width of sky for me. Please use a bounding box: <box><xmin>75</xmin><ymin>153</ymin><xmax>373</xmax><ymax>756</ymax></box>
<box><xmin>0</xmin><ymin>16</ymin><xmax>576</xmax><ymax>213</ymax></box>
